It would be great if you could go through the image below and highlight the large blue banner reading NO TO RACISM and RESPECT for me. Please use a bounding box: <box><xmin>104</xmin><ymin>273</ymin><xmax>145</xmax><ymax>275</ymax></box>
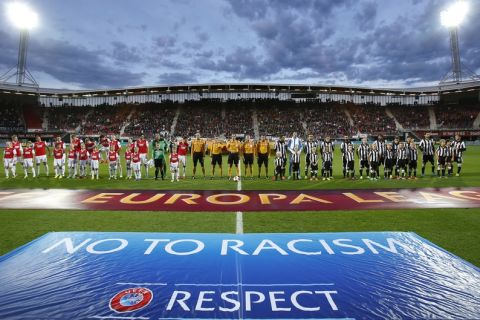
<box><xmin>0</xmin><ymin>232</ymin><xmax>480</xmax><ymax>320</ymax></box>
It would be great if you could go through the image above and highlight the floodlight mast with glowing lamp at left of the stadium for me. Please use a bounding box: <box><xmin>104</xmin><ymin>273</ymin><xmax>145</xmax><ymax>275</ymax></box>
<box><xmin>0</xmin><ymin>1</ymin><xmax>38</xmax><ymax>87</ymax></box>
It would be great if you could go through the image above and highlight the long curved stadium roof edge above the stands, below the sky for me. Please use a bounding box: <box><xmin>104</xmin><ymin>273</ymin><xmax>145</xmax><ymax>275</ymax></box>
<box><xmin>0</xmin><ymin>81</ymin><xmax>480</xmax><ymax>97</ymax></box>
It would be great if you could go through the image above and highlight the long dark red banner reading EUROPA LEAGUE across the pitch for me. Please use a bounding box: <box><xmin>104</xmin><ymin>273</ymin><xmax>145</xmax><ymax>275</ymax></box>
<box><xmin>0</xmin><ymin>188</ymin><xmax>480</xmax><ymax>212</ymax></box>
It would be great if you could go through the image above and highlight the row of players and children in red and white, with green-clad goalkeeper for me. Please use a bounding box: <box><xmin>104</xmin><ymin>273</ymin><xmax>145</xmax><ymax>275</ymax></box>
<box><xmin>4</xmin><ymin>135</ymin><xmax>188</xmax><ymax>181</ymax></box>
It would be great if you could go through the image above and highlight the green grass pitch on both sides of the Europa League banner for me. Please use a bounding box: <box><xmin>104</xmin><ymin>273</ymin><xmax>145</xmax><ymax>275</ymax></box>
<box><xmin>0</xmin><ymin>147</ymin><xmax>480</xmax><ymax>266</ymax></box>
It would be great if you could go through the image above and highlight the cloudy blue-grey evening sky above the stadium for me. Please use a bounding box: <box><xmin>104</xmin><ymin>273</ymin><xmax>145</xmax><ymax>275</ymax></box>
<box><xmin>0</xmin><ymin>0</ymin><xmax>480</xmax><ymax>89</ymax></box>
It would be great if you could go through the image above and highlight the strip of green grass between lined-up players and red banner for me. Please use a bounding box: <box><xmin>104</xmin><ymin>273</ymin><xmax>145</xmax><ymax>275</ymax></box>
<box><xmin>0</xmin><ymin>147</ymin><xmax>480</xmax><ymax>190</ymax></box>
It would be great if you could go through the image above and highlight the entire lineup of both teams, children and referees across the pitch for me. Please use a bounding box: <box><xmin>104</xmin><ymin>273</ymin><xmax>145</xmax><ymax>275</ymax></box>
<box><xmin>3</xmin><ymin>133</ymin><xmax>466</xmax><ymax>182</ymax></box>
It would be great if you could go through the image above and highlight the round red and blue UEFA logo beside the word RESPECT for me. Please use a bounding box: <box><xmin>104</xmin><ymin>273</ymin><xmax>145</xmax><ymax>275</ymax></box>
<box><xmin>110</xmin><ymin>288</ymin><xmax>153</xmax><ymax>313</ymax></box>
